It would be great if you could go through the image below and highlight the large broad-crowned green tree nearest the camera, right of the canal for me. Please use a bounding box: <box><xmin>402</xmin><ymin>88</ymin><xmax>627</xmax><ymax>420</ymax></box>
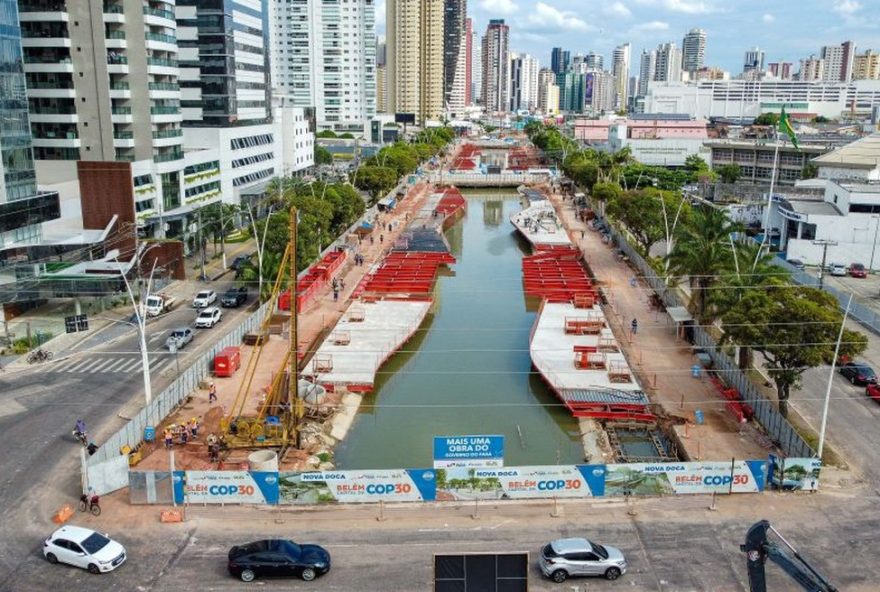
<box><xmin>724</xmin><ymin>282</ymin><xmax>868</xmax><ymax>416</ymax></box>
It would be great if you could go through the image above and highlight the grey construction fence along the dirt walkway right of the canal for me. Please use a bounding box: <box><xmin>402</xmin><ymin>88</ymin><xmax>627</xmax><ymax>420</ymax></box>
<box><xmin>609</xmin><ymin>227</ymin><xmax>820</xmax><ymax>458</ymax></box>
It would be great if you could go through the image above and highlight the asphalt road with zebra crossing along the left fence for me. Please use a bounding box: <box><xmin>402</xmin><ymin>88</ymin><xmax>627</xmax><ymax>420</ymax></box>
<box><xmin>0</xmin><ymin>282</ymin><xmax>253</xmax><ymax>589</ymax></box>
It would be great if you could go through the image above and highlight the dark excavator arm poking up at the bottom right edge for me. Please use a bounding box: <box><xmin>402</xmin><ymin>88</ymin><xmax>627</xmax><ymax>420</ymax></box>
<box><xmin>739</xmin><ymin>520</ymin><xmax>837</xmax><ymax>592</ymax></box>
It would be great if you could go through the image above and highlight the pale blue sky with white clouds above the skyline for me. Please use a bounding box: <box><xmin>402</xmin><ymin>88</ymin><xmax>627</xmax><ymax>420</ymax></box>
<box><xmin>376</xmin><ymin>0</ymin><xmax>880</xmax><ymax>74</ymax></box>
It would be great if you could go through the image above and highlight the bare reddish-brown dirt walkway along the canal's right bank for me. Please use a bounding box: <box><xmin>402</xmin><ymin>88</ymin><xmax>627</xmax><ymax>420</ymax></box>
<box><xmin>550</xmin><ymin>194</ymin><xmax>769</xmax><ymax>460</ymax></box>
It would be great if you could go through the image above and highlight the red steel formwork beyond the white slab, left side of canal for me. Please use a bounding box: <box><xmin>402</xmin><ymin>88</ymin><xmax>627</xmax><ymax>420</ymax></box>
<box><xmin>356</xmin><ymin>251</ymin><xmax>455</xmax><ymax>294</ymax></box>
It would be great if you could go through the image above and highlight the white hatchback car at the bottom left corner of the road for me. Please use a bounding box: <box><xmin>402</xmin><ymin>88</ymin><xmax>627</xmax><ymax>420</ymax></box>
<box><xmin>43</xmin><ymin>525</ymin><xmax>126</xmax><ymax>574</ymax></box>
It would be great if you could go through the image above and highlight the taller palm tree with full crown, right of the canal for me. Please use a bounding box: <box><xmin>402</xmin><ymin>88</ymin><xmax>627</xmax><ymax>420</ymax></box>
<box><xmin>668</xmin><ymin>206</ymin><xmax>740</xmax><ymax>324</ymax></box>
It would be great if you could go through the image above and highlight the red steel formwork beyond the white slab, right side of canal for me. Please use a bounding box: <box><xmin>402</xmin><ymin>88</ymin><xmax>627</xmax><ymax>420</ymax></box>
<box><xmin>523</xmin><ymin>247</ymin><xmax>597</xmax><ymax>302</ymax></box>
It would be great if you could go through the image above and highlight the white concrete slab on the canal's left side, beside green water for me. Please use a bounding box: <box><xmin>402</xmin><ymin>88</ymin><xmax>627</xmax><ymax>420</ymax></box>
<box><xmin>305</xmin><ymin>300</ymin><xmax>432</xmax><ymax>385</ymax></box>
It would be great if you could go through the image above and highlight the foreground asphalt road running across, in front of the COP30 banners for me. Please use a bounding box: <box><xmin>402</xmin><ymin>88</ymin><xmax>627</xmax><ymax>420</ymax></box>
<box><xmin>0</xmin><ymin>494</ymin><xmax>880</xmax><ymax>592</ymax></box>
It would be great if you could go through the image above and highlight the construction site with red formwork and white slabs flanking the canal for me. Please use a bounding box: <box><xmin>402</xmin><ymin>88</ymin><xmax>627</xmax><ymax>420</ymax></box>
<box><xmin>132</xmin><ymin>136</ymin><xmax>773</xmax><ymax>478</ymax></box>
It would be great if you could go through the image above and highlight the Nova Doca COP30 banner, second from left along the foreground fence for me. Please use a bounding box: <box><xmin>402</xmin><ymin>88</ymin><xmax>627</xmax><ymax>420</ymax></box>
<box><xmin>278</xmin><ymin>469</ymin><xmax>436</xmax><ymax>504</ymax></box>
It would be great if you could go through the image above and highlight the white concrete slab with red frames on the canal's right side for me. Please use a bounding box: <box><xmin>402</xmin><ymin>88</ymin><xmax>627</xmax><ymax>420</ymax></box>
<box><xmin>529</xmin><ymin>302</ymin><xmax>642</xmax><ymax>391</ymax></box>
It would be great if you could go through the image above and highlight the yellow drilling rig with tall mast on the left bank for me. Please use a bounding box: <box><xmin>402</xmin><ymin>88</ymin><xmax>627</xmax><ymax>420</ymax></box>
<box><xmin>220</xmin><ymin>208</ymin><xmax>305</xmax><ymax>448</ymax></box>
